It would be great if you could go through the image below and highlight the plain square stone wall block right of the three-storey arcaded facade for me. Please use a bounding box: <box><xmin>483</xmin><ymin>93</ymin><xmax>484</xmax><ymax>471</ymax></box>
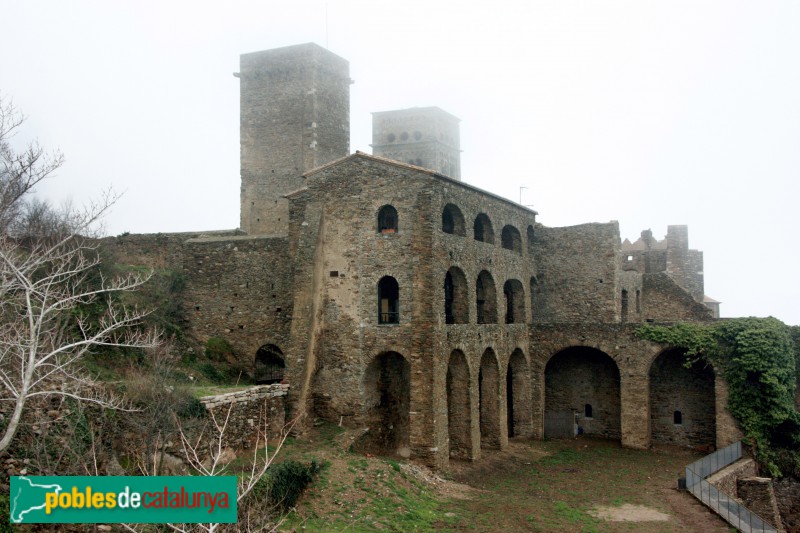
<box><xmin>534</xmin><ymin>222</ymin><xmax>620</xmax><ymax>322</ymax></box>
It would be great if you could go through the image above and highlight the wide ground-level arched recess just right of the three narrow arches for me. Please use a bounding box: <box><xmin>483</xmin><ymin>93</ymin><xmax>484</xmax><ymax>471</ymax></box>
<box><xmin>544</xmin><ymin>346</ymin><xmax>621</xmax><ymax>439</ymax></box>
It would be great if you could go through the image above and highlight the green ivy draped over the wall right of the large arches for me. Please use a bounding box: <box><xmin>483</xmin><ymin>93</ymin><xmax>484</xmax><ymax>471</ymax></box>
<box><xmin>637</xmin><ymin>318</ymin><xmax>800</xmax><ymax>477</ymax></box>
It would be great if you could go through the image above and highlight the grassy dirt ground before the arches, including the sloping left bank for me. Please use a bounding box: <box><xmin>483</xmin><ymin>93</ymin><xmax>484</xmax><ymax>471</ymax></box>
<box><xmin>280</xmin><ymin>432</ymin><xmax>731</xmax><ymax>533</ymax></box>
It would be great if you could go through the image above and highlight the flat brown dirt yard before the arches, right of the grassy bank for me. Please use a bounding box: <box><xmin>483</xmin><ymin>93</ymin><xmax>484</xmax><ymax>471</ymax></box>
<box><xmin>440</xmin><ymin>439</ymin><xmax>731</xmax><ymax>533</ymax></box>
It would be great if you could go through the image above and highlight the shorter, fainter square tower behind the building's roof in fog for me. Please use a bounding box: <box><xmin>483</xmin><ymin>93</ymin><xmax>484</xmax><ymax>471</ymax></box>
<box><xmin>372</xmin><ymin>107</ymin><xmax>461</xmax><ymax>180</ymax></box>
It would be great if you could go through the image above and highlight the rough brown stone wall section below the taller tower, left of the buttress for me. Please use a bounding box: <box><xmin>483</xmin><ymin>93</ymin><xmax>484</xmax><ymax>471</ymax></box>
<box><xmin>184</xmin><ymin>236</ymin><xmax>293</xmax><ymax>368</ymax></box>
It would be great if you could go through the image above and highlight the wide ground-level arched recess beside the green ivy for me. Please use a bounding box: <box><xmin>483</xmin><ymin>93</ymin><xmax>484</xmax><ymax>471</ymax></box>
<box><xmin>650</xmin><ymin>348</ymin><xmax>717</xmax><ymax>446</ymax></box>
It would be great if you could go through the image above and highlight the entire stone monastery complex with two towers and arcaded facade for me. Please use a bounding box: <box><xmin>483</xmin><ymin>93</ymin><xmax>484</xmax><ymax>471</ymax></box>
<box><xmin>109</xmin><ymin>44</ymin><xmax>738</xmax><ymax>467</ymax></box>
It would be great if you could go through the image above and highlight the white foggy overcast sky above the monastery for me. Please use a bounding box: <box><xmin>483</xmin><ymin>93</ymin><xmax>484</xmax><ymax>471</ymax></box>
<box><xmin>0</xmin><ymin>0</ymin><xmax>800</xmax><ymax>324</ymax></box>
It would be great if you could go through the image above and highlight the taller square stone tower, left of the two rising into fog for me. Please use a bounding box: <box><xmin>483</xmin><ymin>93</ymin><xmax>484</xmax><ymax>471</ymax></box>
<box><xmin>238</xmin><ymin>43</ymin><xmax>351</xmax><ymax>235</ymax></box>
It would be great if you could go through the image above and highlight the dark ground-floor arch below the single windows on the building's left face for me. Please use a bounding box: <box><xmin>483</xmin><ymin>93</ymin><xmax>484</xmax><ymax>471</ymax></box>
<box><xmin>356</xmin><ymin>352</ymin><xmax>411</xmax><ymax>457</ymax></box>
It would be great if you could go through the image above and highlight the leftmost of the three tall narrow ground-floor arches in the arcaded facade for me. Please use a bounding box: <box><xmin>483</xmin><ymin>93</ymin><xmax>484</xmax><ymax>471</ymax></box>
<box><xmin>447</xmin><ymin>350</ymin><xmax>472</xmax><ymax>459</ymax></box>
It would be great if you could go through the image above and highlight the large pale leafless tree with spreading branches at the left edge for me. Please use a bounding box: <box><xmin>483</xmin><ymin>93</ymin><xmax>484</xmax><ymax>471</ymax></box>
<box><xmin>0</xmin><ymin>94</ymin><xmax>158</xmax><ymax>453</ymax></box>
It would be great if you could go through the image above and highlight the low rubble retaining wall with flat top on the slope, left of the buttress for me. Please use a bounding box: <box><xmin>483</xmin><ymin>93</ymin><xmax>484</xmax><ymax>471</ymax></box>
<box><xmin>200</xmin><ymin>384</ymin><xmax>289</xmax><ymax>450</ymax></box>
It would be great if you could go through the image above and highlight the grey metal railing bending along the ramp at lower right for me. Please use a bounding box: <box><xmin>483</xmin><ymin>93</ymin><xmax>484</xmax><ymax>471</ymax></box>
<box><xmin>686</xmin><ymin>441</ymin><xmax>777</xmax><ymax>533</ymax></box>
